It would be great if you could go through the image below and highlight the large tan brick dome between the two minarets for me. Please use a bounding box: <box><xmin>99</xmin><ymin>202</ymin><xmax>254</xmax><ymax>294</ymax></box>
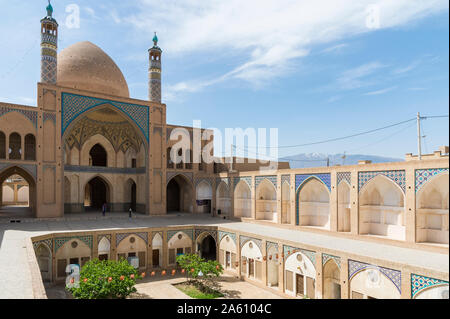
<box><xmin>57</xmin><ymin>41</ymin><xmax>130</xmax><ymax>98</ymax></box>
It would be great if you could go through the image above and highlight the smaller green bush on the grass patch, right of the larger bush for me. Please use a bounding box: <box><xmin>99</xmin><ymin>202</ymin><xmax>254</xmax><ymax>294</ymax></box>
<box><xmin>177</xmin><ymin>254</ymin><xmax>223</xmax><ymax>291</ymax></box>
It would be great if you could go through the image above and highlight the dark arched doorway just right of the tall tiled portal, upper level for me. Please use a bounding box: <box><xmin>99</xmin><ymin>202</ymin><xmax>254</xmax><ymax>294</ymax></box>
<box><xmin>166</xmin><ymin>175</ymin><xmax>193</xmax><ymax>213</ymax></box>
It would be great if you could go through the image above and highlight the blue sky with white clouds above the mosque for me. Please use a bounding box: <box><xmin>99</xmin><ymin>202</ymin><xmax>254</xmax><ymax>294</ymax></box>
<box><xmin>0</xmin><ymin>0</ymin><xmax>449</xmax><ymax>158</ymax></box>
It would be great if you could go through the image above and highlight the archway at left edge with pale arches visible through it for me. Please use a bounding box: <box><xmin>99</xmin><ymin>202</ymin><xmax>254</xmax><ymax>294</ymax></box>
<box><xmin>0</xmin><ymin>166</ymin><xmax>36</xmax><ymax>218</ymax></box>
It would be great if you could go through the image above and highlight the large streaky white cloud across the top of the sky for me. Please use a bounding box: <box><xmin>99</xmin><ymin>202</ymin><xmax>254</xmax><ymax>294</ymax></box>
<box><xmin>122</xmin><ymin>0</ymin><xmax>448</xmax><ymax>95</ymax></box>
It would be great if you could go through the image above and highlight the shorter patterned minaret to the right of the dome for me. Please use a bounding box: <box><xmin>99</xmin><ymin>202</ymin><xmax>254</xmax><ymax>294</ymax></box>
<box><xmin>148</xmin><ymin>32</ymin><xmax>162</xmax><ymax>103</ymax></box>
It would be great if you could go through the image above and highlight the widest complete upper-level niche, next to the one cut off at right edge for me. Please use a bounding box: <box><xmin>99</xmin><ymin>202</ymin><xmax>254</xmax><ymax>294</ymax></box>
<box><xmin>359</xmin><ymin>175</ymin><xmax>405</xmax><ymax>240</ymax></box>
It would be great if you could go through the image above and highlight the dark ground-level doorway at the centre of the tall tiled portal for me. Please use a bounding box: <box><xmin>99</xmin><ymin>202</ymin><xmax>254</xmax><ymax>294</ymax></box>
<box><xmin>84</xmin><ymin>176</ymin><xmax>110</xmax><ymax>211</ymax></box>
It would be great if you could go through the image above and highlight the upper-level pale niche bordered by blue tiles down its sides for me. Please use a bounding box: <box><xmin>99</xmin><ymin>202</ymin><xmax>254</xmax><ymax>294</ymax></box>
<box><xmin>297</xmin><ymin>178</ymin><xmax>330</xmax><ymax>229</ymax></box>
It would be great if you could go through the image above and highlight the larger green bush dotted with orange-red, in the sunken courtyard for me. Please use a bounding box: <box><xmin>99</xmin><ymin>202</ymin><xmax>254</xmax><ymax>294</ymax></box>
<box><xmin>67</xmin><ymin>259</ymin><xmax>140</xmax><ymax>299</ymax></box>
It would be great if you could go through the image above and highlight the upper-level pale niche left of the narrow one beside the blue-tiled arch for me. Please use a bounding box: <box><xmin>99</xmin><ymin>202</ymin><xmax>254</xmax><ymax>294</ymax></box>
<box><xmin>255</xmin><ymin>179</ymin><xmax>278</xmax><ymax>223</ymax></box>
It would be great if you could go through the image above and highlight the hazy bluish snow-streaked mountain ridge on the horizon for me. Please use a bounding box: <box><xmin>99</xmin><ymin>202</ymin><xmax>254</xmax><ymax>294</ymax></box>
<box><xmin>280</xmin><ymin>153</ymin><xmax>404</xmax><ymax>168</ymax></box>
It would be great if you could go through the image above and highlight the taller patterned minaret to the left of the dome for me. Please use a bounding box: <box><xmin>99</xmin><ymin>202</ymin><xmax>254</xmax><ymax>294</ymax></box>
<box><xmin>41</xmin><ymin>0</ymin><xmax>58</xmax><ymax>84</ymax></box>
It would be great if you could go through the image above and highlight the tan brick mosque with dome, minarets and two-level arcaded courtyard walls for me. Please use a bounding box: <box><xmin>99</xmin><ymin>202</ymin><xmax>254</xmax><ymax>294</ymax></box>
<box><xmin>0</xmin><ymin>5</ymin><xmax>449</xmax><ymax>299</ymax></box>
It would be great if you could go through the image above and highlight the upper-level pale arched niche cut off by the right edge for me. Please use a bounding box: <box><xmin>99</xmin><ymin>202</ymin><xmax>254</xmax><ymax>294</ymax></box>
<box><xmin>416</xmin><ymin>173</ymin><xmax>449</xmax><ymax>245</ymax></box>
